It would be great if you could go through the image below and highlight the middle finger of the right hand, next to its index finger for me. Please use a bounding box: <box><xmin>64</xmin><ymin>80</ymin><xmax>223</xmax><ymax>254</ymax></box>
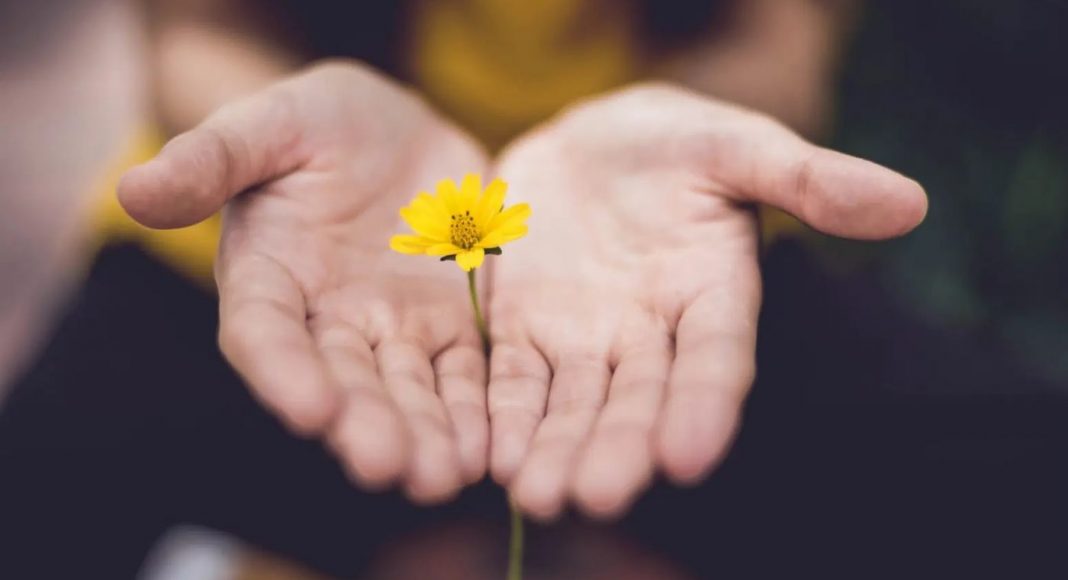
<box><xmin>571</xmin><ymin>336</ymin><xmax>672</xmax><ymax>518</ymax></box>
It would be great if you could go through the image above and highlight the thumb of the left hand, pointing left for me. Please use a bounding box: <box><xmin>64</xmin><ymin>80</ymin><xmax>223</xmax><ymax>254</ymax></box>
<box><xmin>117</xmin><ymin>89</ymin><xmax>303</xmax><ymax>229</ymax></box>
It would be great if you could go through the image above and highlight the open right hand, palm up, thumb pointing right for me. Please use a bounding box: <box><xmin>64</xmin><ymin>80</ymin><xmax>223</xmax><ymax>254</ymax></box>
<box><xmin>488</xmin><ymin>85</ymin><xmax>926</xmax><ymax>518</ymax></box>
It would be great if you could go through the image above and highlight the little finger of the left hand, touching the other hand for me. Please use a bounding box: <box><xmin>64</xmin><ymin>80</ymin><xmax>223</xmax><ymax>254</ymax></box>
<box><xmin>434</xmin><ymin>345</ymin><xmax>489</xmax><ymax>483</ymax></box>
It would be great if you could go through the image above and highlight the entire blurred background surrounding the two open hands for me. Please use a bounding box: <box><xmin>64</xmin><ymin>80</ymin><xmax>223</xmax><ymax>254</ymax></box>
<box><xmin>0</xmin><ymin>0</ymin><xmax>1068</xmax><ymax>580</ymax></box>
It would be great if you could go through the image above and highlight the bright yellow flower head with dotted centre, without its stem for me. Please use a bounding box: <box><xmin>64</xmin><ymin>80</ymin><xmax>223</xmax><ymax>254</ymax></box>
<box><xmin>390</xmin><ymin>173</ymin><xmax>531</xmax><ymax>271</ymax></box>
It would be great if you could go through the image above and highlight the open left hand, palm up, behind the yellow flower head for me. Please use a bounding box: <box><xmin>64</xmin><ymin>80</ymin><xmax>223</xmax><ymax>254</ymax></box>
<box><xmin>119</xmin><ymin>63</ymin><xmax>488</xmax><ymax>502</ymax></box>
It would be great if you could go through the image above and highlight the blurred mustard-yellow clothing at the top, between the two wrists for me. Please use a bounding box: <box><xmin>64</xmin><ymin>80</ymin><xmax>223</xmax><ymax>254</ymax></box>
<box><xmin>409</xmin><ymin>0</ymin><xmax>641</xmax><ymax>150</ymax></box>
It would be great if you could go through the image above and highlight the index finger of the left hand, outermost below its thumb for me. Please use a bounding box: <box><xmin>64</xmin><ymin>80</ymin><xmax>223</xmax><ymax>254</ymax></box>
<box><xmin>217</xmin><ymin>255</ymin><xmax>340</xmax><ymax>435</ymax></box>
